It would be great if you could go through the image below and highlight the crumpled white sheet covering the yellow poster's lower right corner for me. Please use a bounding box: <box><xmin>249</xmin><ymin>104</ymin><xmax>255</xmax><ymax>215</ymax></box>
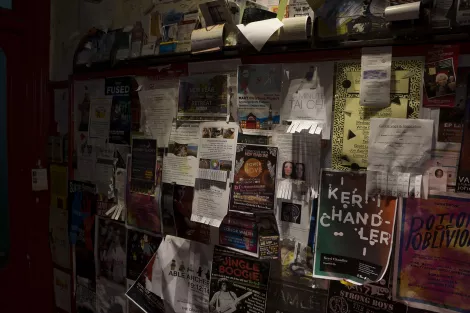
<box><xmin>367</xmin><ymin>118</ymin><xmax>434</xmax><ymax>174</ymax></box>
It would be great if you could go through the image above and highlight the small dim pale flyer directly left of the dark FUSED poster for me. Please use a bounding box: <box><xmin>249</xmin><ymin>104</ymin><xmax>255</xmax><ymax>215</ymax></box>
<box><xmin>88</xmin><ymin>98</ymin><xmax>112</xmax><ymax>138</ymax></box>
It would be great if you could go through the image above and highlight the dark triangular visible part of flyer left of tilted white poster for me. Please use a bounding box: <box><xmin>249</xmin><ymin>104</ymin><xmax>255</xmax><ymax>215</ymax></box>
<box><xmin>126</xmin><ymin>229</ymin><xmax>162</xmax><ymax>280</ymax></box>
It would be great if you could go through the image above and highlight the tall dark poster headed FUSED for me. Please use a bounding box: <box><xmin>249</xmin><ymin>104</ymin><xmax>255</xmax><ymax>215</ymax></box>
<box><xmin>105</xmin><ymin>77</ymin><xmax>133</xmax><ymax>145</ymax></box>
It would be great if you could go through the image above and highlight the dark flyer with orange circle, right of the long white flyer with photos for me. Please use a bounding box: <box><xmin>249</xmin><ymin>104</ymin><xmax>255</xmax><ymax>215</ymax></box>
<box><xmin>230</xmin><ymin>144</ymin><xmax>278</xmax><ymax>212</ymax></box>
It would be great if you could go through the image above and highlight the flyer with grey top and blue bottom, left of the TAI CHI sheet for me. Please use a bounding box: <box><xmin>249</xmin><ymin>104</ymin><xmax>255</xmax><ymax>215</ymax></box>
<box><xmin>237</xmin><ymin>64</ymin><xmax>282</xmax><ymax>129</ymax></box>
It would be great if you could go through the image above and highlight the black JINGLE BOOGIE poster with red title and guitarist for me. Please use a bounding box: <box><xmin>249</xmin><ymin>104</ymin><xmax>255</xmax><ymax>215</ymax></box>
<box><xmin>209</xmin><ymin>246</ymin><xmax>270</xmax><ymax>313</ymax></box>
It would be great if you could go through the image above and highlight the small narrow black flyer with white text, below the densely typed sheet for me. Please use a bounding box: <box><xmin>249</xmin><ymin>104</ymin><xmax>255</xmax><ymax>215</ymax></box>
<box><xmin>131</xmin><ymin>138</ymin><xmax>157</xmax><ymax>194</ymax></box>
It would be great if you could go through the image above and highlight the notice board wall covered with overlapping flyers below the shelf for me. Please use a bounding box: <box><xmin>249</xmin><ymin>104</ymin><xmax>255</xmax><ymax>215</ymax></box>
<box><xmin>49</xmin><ymin>44</ymin><xmax>470</xmax><ymax>313</ymax></box>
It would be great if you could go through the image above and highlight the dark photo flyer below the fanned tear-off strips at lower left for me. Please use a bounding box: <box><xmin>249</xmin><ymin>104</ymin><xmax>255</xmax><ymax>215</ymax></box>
<box><xmin>96</xmin><ymin>218</ymin><xmax>126</xmax><ymax>286</ymax></box>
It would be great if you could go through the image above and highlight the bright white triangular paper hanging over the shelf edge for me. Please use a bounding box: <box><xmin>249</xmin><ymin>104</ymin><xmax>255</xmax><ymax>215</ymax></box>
<box><xmin>237</xmin><ymin>18</ymin><xmax>284</xmax><ymax>51</ymax></box>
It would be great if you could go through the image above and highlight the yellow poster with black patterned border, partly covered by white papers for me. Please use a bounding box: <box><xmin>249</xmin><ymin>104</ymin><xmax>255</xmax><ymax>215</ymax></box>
<box><xmin>331</xmin><ymin>58</ymin><xmax>423</xmax><ymax>170</ymax></box>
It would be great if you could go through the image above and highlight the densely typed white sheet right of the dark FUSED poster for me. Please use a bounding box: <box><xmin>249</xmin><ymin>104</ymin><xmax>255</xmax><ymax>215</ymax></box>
<box><xmin>139</xmin><ymin>88</ymin><xmax>178</xmax><ymax>148</ymax></box>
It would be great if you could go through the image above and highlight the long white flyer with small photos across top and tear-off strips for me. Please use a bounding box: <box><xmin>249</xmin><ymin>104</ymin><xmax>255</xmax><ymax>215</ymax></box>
<box><xmin>191</xmin><ymin>122</ymin><xmax>238</xmax><ymax>227</ymax></box>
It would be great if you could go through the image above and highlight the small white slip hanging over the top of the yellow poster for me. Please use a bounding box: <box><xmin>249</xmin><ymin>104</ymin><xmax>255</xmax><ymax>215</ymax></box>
<box><xmin>359</xmin><ymin>46</ymin><xmax>392</xmax><ymax>107</ymax></box>
